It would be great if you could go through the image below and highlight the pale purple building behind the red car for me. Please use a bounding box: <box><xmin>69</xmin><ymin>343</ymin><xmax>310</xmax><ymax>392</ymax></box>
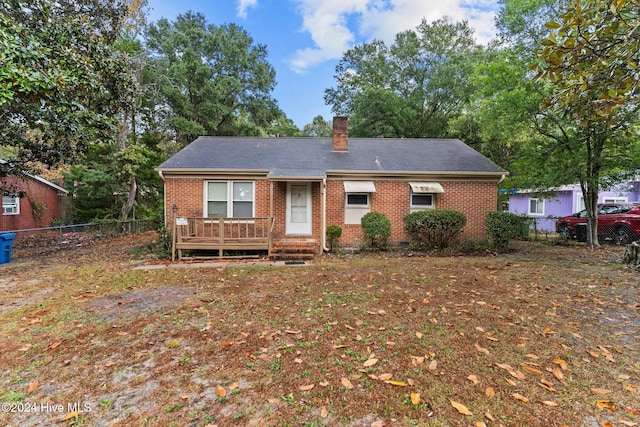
<box><xmin>509</xmin><ymin>180</ymin><xmax>640</xmax><ymax>232</ymax></box>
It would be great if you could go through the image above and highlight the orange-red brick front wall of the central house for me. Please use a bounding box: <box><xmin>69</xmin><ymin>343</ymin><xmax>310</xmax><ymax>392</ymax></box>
<box><xmin>165</xmin><ymin>178</ymin><xmax>498</xmax><ymax>246</ymax></box>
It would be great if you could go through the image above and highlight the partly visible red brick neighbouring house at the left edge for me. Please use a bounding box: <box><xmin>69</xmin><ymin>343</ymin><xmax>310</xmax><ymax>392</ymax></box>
<box><xmin>0</xmin><ymin>174</ymin><xmax>69</xmax><ymax>232</ymax></box>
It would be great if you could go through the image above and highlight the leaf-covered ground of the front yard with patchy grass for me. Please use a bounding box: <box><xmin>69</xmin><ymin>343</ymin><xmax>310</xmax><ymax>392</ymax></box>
<box><xmin>0</xmin><ymin>234</ymin><xmax>640</xmax><ymax>427</ymax></box>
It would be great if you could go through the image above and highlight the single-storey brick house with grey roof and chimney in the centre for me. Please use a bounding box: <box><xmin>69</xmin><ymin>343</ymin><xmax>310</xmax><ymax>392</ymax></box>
<box><xmin>157</xmin><ymin>117</ymin><xmax>507</xmax><ymax>257</ymax></box>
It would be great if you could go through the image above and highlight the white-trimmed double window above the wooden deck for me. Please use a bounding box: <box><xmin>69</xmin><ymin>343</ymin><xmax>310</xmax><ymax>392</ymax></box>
<box><xmin>205</xmin><ymin>181</ymin><xmax>255</xmax><ymax>218</ymax></box>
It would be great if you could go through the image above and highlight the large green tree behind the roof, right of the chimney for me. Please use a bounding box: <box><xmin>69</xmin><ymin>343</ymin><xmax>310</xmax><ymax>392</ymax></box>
<box><xmin>324</xmin><ymin>18</ymin><xmax>481</xmax><ymax>137</ymax></box>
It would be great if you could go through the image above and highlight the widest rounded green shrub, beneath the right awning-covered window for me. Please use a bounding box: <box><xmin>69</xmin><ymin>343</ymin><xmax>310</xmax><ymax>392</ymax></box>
<box><xmin>403</xmin><ymin>209</ymin><xmax>467</xmax><ymax>249</ymax></box>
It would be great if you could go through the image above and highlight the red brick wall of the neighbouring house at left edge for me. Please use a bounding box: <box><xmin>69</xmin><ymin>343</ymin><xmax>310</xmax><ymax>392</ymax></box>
<box><xmin>0</xmin><ymin>177</ymin><xmax>59</xmax><ymax>231</ymax></box>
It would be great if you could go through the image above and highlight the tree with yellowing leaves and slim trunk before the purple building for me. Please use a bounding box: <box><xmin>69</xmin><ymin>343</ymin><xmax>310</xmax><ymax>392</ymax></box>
<box><xmin>537</xmin><ymin>0</ymin><xmax>640</xmax><ymax>244</ymax></box>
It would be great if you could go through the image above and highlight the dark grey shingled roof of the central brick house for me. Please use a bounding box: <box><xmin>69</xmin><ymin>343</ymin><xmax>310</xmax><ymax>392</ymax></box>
<box><xmin>157</xmin><ymin>137</ymin><xmax>507</xmax><ymax>178</ymax></box>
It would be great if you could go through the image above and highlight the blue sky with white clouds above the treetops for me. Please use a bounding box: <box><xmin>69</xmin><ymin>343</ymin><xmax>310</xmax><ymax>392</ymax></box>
<box><xmin>148</xmin><ymin>0</ymin><xmax>498</xmax><ymax>128</ymax></box>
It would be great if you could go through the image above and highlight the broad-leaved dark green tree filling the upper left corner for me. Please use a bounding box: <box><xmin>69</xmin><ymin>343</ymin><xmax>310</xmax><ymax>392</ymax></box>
<box><xmin>0</xmin><ymin>0</ymin><xmax>132</xmax><ymax>182</ymax></box>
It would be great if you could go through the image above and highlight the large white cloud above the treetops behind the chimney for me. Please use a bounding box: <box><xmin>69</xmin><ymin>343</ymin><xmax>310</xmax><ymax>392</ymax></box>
<box><xmin>289</xmin><ymin>0</ymin><xmax>497</xmax><ymax>73</ymax></box>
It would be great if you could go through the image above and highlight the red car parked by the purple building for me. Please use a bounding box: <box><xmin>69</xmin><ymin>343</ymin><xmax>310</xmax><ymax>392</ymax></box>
<box><xmin>556</xmin><ymin>203</ymin><xmax>640</xmax><ymax>245</ymax></box>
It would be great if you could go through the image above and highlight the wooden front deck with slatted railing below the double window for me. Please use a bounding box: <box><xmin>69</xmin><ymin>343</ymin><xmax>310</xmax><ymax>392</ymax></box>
<box><xmin>171</xmin><ymin>218</ymin><xmax>273</xmax><ymax>261</ymax></box>
